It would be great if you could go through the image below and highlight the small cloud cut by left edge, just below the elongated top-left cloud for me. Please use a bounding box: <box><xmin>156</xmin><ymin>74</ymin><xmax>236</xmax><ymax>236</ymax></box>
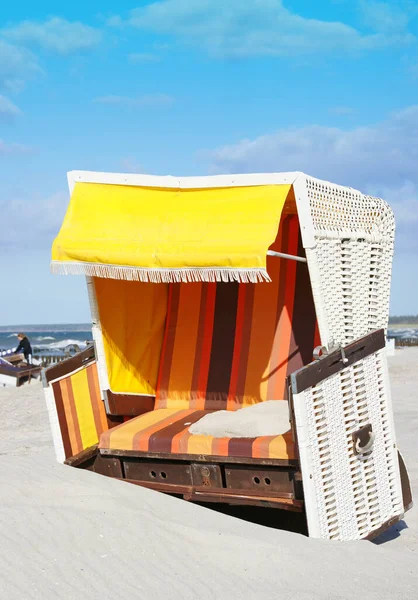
<box><xmin>0</xmin><ymin>38</ymin><xmax>42</xmax><ymax>92</ymax></box>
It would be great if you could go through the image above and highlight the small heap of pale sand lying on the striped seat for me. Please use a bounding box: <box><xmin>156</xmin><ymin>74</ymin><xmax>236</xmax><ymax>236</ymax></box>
<box><xmin>189</xmin><ymin>400</ymin><xmax>290</xmax><ymax>438</ymax></box>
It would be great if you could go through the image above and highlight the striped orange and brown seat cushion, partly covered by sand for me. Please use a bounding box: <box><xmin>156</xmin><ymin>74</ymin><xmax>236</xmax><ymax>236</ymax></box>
<box><xmin>99</xmin><ymin>408</ymin><xmax>295</xmax><ymax>460</ymax></box>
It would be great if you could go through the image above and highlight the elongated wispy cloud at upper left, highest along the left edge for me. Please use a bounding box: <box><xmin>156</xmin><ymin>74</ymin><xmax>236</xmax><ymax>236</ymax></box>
<box><xmin>1</xmin><ymin>17</ymin><xmax>102</xmax><ymax>54</ymax></box>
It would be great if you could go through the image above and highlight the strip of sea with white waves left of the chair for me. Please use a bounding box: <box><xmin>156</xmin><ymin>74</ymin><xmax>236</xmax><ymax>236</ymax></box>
<box><xmin>0</xmin><ymin>324</ymin><xmax>93</xmax><ymax>355</ymax></box>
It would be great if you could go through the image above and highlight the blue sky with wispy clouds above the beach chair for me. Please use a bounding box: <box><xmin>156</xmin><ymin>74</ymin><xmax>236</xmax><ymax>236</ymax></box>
<box><xmin>0</xmin><ymin>0</ymin><xmax>418</xmax><ymax>325</ymax></box>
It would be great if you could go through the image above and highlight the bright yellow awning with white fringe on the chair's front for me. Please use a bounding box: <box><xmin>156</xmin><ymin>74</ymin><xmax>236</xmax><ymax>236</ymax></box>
<box><xmin>52</xmin><ymin>183</ymin><xmax>291</xmax><ymax>283</ymax></box>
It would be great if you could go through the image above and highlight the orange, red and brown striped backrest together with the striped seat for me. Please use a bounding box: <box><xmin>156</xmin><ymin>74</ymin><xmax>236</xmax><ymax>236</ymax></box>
<box><xmin>99</xmin><ymin>215</ymin><xmax>319</xmax><ymax>459</ymax></box>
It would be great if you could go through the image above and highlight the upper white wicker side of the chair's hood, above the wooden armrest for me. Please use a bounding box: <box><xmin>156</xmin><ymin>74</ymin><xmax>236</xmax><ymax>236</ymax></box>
<box><xmin>306</xmin><ymin>177</ymin><xmax>395</xmax><ymax>347</ymax></box>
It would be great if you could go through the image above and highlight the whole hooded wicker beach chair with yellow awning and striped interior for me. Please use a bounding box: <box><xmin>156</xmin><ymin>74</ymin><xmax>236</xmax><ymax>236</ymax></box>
<box><xmin>43</xmin><ymin>172</ymin><xmax>412</xmax><ymax>540</ymax></box>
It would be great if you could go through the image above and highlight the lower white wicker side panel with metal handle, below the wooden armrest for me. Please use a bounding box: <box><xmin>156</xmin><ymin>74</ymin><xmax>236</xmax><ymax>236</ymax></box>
<box><xmin>294</xmin><ymin>350</ymin><xmax>403</xmax><ymax>540</ymax></box>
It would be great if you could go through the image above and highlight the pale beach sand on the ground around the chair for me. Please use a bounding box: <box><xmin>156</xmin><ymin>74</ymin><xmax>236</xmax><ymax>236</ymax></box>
<box><xmin>0</xmin><ymin>349</ymin><xmax>418</xmax><ymax>600</ymax></box>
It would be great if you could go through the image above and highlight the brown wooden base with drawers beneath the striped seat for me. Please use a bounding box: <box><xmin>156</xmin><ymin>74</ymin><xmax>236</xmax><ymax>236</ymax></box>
<box><xmin>65</xmin><ymin>446</ymin><xmax>303</xmax><ymax>512</ymax></box>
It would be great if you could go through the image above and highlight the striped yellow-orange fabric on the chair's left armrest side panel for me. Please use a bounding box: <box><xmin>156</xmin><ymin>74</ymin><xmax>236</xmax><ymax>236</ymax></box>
<box><xmin>51</xmin><ymin>363</ymin><xmax>108</xmax><ymax>458</ymax></box>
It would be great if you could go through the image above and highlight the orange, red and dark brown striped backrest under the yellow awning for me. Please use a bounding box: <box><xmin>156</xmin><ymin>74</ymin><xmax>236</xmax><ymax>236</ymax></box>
<box><xmin>155</xmin><ymin>216</ymin><xmax>316</xmax><ymax>410</ymax></box>
